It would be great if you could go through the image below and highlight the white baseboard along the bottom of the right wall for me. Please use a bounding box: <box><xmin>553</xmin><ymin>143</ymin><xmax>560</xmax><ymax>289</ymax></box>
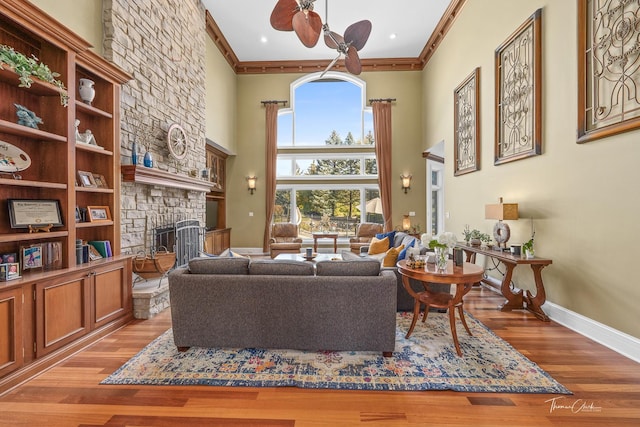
<box><xmin>542</xmin><ymin>301</ymin><xmax>640</xmax><ymax>363</ymax></box>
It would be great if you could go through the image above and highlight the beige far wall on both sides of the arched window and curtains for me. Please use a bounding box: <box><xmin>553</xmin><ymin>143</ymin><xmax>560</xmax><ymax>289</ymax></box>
<box><xmin>227</xmin><ymin>72</ymin><xmax>425</xmax><ymax>247</ymax></box>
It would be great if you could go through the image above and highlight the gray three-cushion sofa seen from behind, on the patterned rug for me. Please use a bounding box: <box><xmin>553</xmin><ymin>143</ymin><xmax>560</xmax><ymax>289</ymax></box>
<box><xmin>169</xmin><ymin>258</ymin><xmax>396</xmax><ymax>356</ymax></box>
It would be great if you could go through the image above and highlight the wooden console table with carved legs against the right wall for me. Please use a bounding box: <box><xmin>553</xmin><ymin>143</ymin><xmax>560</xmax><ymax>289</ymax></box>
<box><xmin>456</xmin><ymin>244</ymin><xmax>553</xmax><ymax>322</ymax></box>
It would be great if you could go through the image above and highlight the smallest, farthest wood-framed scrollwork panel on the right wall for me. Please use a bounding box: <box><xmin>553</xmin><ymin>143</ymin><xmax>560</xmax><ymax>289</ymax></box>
<box><xmin>453</xmin><ymin>68</ymin><xmax>480</xmax><ymax>176</ymax></box>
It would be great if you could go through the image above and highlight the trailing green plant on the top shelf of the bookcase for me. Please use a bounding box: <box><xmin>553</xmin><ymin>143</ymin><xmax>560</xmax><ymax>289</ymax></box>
<box><xmin>0</xmin><ymin>44</ymin><xmax>69</xmax><ymax>107</ymax></box>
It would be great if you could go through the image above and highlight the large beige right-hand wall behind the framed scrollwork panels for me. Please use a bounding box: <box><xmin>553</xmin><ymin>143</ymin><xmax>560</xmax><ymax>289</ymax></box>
<box><xmin>423</xmin><ymin>0</ymin><xmax>640</xmax><ymax>337</ymax></box>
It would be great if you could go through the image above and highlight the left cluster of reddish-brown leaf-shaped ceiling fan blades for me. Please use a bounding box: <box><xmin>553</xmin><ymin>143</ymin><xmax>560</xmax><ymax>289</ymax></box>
<box><xmin>271</xmin><ymin>0</ymin><xmax>322</xmax><ymax>47</ymax></box>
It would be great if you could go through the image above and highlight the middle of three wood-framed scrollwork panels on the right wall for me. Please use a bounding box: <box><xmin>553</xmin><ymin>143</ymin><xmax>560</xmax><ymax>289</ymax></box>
<box><xmin>494</xmin><ymin>9</ymin><xmax>542</xmax><ymax>165</ymax></box>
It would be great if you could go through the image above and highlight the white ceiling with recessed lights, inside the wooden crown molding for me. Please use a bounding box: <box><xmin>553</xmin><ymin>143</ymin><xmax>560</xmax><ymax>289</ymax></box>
<box><xmin>202</xmin><ymin>0</ymin><xmax>450</xmax><ymax>62</ymax></box>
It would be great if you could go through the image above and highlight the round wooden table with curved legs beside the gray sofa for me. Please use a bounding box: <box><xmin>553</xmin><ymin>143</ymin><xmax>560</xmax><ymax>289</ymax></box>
<box><xmin>396</xmin><ymin>260</ymin><xmax>484</xmax><ymax>356</ymax></box>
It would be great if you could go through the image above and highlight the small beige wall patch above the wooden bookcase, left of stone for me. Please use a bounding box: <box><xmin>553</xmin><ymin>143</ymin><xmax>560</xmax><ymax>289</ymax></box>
<box><xmin>31</xmin><ymin>0</ymin><xmax>102</xmax><ymax>54</ymax></box>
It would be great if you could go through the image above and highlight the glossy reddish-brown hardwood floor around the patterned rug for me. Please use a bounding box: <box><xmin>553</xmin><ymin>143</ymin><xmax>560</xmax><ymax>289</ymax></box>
<box><xmin>0</xmin><ymin>289</ymin><xmax>640</xmax><ymax>427</ymax></box>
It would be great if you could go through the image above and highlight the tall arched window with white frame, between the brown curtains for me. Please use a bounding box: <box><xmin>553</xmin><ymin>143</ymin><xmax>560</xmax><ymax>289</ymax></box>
<box><xmin>273</xmin><ymin>72</ymin><xmax>382</xmax><ymax>242</ymax></box>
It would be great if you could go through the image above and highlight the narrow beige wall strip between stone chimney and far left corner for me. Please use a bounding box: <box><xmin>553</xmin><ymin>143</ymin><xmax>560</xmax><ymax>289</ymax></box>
<box><xmin>205</xmin><ymin>37</ymin><xmax>238</xmax><ymax>152</ymax></box>
